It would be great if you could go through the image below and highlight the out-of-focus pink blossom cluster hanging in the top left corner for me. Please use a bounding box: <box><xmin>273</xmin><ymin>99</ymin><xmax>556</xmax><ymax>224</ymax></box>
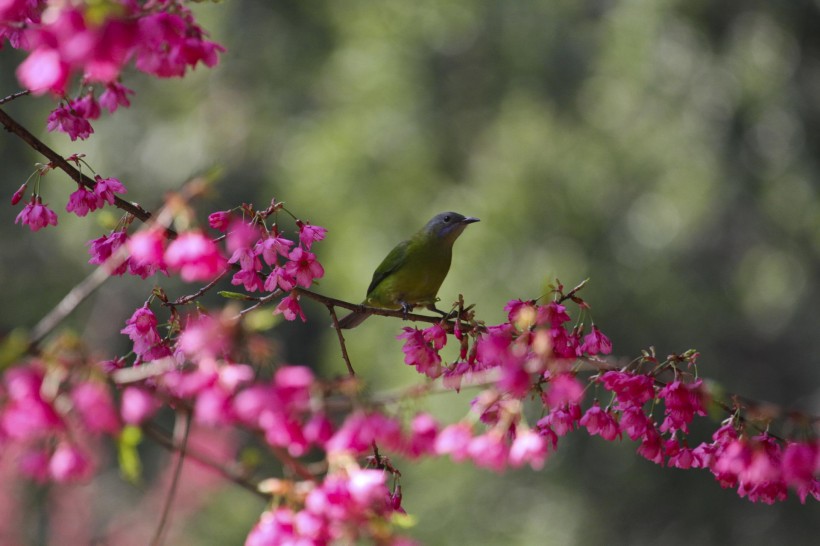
<box><xmin>0</xmin><ymin>0</ymin><xmax>225</xmax><ymax>140</ymax></box>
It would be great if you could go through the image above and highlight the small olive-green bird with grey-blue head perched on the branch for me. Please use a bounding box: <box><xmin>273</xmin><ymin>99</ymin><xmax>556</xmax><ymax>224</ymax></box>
<box><xmin>339</xmin><ymin>212</ymin><xmax>478</xmax><ymax>328</ymax></box>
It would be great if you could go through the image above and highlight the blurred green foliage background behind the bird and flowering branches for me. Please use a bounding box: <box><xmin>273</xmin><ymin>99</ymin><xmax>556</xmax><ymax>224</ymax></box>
<box><xmin>0</xmin><ymin>0</ymin><xmax>820</xmax><ymax>545</ymax></box>
